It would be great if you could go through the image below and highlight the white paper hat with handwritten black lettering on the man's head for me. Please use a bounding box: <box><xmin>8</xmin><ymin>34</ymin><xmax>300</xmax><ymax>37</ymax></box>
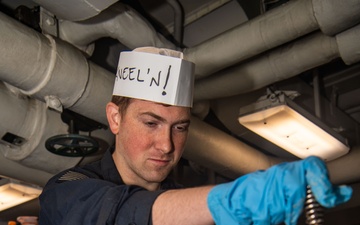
<box><xmin>113</xmin><ymin>47</ymin><xmax>194</xmax><ymax>107</ymax></box>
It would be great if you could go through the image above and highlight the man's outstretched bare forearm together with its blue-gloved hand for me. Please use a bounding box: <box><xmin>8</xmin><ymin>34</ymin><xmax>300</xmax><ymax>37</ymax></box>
<box><xmin>152</xmin><ymin>157</ymin><xmax>352</xmax><ymax>225</ymax></box>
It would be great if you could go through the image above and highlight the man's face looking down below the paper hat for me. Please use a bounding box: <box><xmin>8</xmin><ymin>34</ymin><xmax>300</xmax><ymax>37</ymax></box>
<box><xmin>114</xmin><ymin>99</ymin><xmax>190</xmax><ymax>188</ymax></box>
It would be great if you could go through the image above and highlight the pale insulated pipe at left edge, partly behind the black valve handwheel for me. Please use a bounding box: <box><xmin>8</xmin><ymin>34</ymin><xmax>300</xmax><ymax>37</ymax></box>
<box><xmin>0</xmin><ymin>82</ymin><xmax>80</xmax><ymax>176</ymax></box>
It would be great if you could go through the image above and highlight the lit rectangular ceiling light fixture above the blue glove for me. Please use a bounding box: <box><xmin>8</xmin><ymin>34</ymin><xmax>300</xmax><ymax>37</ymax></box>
<box><xmin>238</xmin><ymin>92</ymin><xmax>349</xmax><ymax>161</ymax></box>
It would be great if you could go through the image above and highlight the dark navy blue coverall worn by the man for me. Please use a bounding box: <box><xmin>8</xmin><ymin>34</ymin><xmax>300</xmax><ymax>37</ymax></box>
<box><xmin>39</xmin><ymin>150</ymin><xmax>180</xmax><ymax>225</ymax></box>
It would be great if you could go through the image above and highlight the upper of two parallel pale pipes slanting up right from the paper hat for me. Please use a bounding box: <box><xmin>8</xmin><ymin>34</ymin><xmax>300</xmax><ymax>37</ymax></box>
<box><xmin>184</xmin><ymin>0</ymin><xmax>360</xmax><ymax>79</ymax></box>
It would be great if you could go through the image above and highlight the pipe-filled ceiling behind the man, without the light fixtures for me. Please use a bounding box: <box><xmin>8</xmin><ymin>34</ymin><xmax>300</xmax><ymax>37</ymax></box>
<box><xmin>0</xmin><ymin>0</ymin><xmax>360</xmax><ymax>225</ymax></box>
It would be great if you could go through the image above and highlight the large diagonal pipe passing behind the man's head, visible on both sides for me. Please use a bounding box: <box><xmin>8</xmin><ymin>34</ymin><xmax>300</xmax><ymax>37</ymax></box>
<box><xmin>0</xmin><ymin>3</ymin><xmax>360</xmax><ymax>186</ymax></box>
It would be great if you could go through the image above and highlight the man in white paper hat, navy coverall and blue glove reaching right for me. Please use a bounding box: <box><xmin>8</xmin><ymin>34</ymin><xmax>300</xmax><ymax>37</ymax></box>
<box><xmin>39</xmin><ymin>48</ymin><xmax>351</xmax><ymax>225</ymax></box>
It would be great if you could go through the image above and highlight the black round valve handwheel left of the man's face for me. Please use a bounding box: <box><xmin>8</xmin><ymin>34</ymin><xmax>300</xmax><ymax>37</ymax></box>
<box><xmin>45</xmin><ymin>134</ymin><xmax>99</xmax><ymax>157</ymax></box>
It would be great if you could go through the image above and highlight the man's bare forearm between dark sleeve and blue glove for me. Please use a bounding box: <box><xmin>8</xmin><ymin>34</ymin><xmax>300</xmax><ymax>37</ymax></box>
<box><xmin>152</xmin><ymin>186</ymin><xmax>214</xmax><ymax>225</ymax></box>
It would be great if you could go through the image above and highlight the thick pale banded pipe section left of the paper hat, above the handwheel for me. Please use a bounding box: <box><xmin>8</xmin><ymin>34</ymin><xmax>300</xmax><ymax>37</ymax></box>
<box><xmin>0</xmin><ymin>13</ymin><xmax>114</xmax><ymax>124</ymax></box>
